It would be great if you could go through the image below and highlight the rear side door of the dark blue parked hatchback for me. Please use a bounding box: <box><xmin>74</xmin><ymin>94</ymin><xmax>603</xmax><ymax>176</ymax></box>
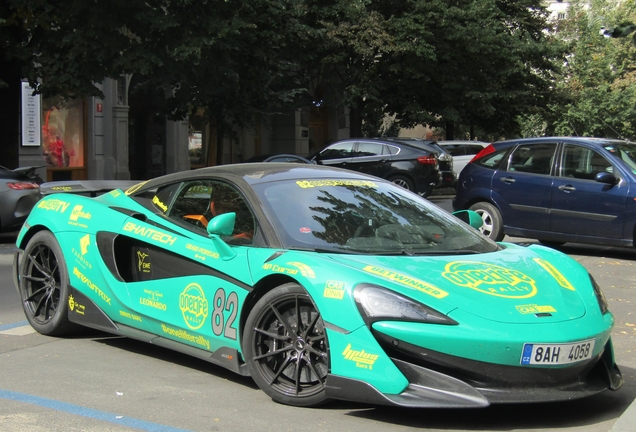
<box><xmin>491</xmin><ymin>142</ymin><xmax>557</xmax><ymax>230</ymax></box>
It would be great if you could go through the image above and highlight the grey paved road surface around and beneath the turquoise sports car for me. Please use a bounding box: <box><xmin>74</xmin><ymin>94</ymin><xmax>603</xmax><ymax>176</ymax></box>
<box><xmin>0</xmin><ymin>204</ymin><xmax>636</xmax><ymax>432</ymax></box>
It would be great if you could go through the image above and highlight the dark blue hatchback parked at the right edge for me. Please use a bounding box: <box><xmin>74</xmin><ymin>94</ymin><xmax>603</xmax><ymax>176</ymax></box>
<box><xmin>453</xmin><ymin>137</ymin><xmax>636</xmax><ymax>246</ymax></box>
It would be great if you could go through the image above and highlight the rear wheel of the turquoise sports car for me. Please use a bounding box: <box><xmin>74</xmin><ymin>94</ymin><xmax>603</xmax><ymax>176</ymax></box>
<box><xmin>18</xmin><ymin>231</ymin><xmax>80</xmax><ymax>336</ymax></box>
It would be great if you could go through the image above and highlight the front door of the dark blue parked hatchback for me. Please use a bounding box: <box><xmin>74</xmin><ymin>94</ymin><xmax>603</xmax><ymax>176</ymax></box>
<box><xmin>551</xmin><ymin>143</ymin><xmax>628</xmax><ymax>239</ymax></box>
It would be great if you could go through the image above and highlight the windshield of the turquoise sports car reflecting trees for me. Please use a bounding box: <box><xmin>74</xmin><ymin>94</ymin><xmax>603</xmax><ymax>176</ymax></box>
<box><xmin>254</xmin><ymin>179</ymin><xmax>499</xmax><ymax>255</ymax></box>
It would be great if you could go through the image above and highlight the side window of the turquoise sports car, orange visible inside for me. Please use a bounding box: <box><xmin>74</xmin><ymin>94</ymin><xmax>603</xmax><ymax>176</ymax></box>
<box><xmin>168</xmin><ymin>180</ymin><xmax>255</xmax><ymax>244</ymax></box>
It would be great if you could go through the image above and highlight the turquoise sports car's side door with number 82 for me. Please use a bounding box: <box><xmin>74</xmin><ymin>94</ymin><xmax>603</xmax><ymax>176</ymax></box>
<box><xmin>123</xmin><ymin>179</ymin><xmax>255</xmax><ymax>351</ymax></box>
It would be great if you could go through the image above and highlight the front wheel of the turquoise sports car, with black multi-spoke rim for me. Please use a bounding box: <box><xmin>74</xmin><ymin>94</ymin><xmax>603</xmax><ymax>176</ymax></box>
<box><xmin>243</xmin><ymin>283</ymin><xmax>329</xmax><ymax>407</ymax></box>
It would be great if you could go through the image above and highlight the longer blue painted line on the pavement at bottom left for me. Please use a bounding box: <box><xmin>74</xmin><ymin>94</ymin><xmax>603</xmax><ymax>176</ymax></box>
<box><xmin>0</xmin><ymin>389</ymin><xmax>191</xmax><ymax>432</ymax></box>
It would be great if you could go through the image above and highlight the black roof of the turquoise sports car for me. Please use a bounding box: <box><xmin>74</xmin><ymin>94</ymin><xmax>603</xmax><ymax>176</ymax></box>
<box><xmin>135</xmin><ymin>162</ymin><xmax>383</xmax><ymax>194</ymax></box>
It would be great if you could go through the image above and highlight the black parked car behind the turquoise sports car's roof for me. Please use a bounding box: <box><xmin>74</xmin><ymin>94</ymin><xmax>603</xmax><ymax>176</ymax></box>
<box><xmin>308</xmin><ymin>138</ymin><xmax>441</xmax><ymax>197</ymax></box>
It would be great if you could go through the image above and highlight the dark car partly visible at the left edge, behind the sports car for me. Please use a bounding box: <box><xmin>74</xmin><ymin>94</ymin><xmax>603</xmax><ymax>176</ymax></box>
<box><xmin>0</xmin><ymin>166</ymin><xmax>42</xmax><ymax>232</ymax></box>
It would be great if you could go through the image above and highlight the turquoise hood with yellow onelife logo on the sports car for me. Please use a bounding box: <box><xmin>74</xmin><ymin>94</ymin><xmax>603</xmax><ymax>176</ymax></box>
<box><xmin>334</xmin><ymin>245</ymin><xmax>595</xmax><ymax>323</ymax></box>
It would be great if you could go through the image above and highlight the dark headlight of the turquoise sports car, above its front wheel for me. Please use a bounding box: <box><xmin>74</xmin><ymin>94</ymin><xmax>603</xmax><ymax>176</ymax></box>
<box><xmin>353</xmin><ymin>284</ymin><xmax>457</xmax><ymax>325</ymax></box>
